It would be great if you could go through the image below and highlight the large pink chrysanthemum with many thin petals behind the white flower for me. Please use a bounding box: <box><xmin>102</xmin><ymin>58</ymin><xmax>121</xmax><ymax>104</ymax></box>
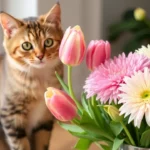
<box><xmin>84</xmin><ymin>53</ymin><xmax>150</xmax><ymax>103</ymax></box>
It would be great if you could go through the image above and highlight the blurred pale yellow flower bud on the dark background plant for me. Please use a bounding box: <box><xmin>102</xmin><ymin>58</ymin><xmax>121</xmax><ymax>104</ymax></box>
<box><xmin>134</xmin><ymin>8</ymin><xmax>146</xmax><ymax>21</ymax></box>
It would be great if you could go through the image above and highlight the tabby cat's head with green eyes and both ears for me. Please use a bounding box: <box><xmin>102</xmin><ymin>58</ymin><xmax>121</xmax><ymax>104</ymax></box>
<box><xmin>0</xmin><ymin>4</ymin><xmax>63</xmax><ymax>68</ymax></box>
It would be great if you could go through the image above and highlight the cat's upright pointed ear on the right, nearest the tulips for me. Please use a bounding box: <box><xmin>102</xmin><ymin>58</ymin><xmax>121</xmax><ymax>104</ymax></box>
<box><xmin>44</xmin><ymin>3</ymin><xmax>61</xmax><ymax>26</ymax></box>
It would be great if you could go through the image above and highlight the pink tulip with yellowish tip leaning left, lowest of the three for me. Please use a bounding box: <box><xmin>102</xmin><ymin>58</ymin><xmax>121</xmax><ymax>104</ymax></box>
<box><xmin>44</xmin><ymin>87</ymin><xmax>77</xmax><ymax>121</ymax></box>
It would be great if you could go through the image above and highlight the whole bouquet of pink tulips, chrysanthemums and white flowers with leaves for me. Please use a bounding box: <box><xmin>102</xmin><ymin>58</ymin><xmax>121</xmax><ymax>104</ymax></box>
<box><xmin>45</xmin><ymin>26</ymin><xmax>150</xmax><ymax>150</ymax></box>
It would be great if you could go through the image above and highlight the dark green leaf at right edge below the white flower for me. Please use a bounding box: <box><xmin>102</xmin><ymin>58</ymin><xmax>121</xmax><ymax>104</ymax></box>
<box><xmin>140</xmin><ymin>129</ymin><xmax>150</xmax><ymax>147</ymax></box>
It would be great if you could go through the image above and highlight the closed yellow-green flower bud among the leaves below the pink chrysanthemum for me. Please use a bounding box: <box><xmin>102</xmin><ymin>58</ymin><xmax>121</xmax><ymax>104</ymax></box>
<box><xmin>104</xmin><ymin>105</ymin><xmax>123</xmax><ymax>122</ymax></box>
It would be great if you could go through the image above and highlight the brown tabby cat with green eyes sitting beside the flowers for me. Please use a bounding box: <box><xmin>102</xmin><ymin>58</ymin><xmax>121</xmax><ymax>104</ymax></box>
<box><xmin>0</xmin><ymin>4</ymin><xmax>63</xmax><ymax>150</ymax></box>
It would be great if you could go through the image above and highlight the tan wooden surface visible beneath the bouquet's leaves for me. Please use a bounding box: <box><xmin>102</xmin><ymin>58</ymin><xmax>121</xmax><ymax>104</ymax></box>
<box><xmin>50</xmin><ymin>124</ymin><xmax>100</xmax><ymax>150</ymax></box>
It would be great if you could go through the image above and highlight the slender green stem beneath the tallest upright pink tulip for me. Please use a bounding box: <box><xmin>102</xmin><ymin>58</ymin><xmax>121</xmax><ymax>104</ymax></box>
<box><xmin>68</xmin><ymin>66</ymin><xmax>82</xmax><ymax>113</ymax></box>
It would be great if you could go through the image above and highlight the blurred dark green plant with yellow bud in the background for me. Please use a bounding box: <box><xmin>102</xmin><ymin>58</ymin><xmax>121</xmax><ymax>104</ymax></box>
<box><xmin>108</xmin><ymin>8</ymin><xmax>150</xmax><ymax>53</ymax></box>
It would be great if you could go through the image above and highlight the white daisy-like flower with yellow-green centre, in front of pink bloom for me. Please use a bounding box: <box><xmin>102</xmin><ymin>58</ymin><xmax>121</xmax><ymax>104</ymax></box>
<box><xmin>119</xmin><ymin>68</ymin><xmax>150</xmax><ymax>128</ymax></box>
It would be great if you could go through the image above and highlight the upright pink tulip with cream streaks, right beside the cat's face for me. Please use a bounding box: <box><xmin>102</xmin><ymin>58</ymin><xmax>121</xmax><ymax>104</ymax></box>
<box><xmin>59</xmin><ymin>26</ymin><xmax>85</xmax><ymax>66</ymax></box>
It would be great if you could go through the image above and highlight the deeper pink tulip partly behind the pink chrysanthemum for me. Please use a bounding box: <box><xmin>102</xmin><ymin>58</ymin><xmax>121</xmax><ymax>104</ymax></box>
<box><xmin>86</xmin><ymin>40</ymin><xmax>111</xmax><ymax>71</ymax></box>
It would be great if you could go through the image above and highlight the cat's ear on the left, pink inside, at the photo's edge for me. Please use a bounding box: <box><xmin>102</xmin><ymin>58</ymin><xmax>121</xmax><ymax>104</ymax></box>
<box><xmin>0</xmin><ymin>13</ymin><xmax>22</xmax><ymax>38</ymax></box>
